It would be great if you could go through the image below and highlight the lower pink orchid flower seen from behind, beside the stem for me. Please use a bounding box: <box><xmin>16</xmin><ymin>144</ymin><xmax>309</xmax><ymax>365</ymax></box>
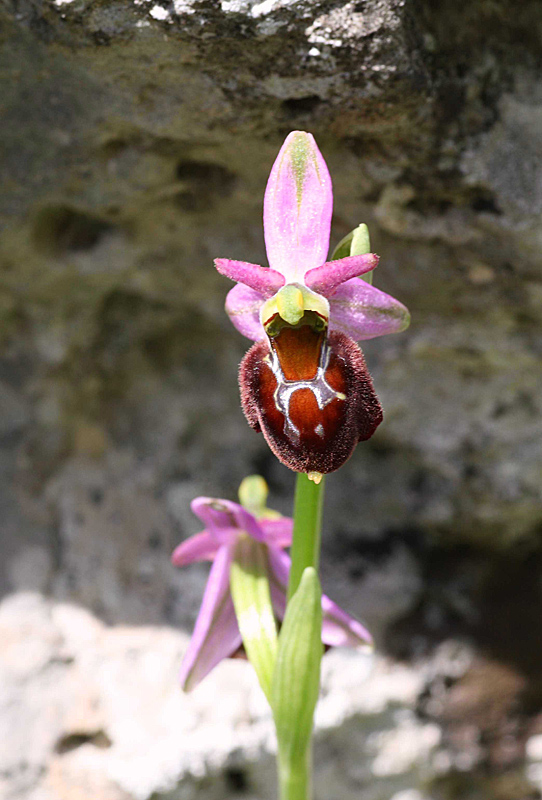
<box><xmin>171</xmin><ymin>490</ymin><xmax>372</xmax><ymax>691</ymax></box>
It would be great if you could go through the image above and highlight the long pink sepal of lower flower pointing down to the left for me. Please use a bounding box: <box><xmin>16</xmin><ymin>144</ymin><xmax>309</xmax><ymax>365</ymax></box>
<box><xmin>180</xmin><ymin>547</ymin><xmax>242</xmax><ymax>692</ymax></box>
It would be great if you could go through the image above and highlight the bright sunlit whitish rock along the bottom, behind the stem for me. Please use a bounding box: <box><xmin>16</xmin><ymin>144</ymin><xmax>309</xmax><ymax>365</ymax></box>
<box><xmin>0</xmin><ymin>593</ymin><xmax>516</xmax><ymax>800</ymax></box>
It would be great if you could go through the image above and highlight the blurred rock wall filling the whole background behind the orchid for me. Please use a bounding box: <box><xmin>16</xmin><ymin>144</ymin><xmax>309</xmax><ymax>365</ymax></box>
<box><xmin>0</xmin><ymin>0</ymin><xmax>542</xmax><ymax>800</ymax></box>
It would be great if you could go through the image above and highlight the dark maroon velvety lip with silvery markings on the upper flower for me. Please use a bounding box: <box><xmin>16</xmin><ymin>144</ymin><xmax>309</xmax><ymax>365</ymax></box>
<box><xmin>239</xmin><ymin>326</ymin><xmax>382</xmax><ymax>473</ymax></box>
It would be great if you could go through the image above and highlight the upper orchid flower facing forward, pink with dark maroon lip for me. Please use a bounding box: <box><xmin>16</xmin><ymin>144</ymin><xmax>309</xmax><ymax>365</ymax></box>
<box><xmin>215</xmin><ymin>131</ymin><xmax>409</xmax><ymax>474</ymax></box>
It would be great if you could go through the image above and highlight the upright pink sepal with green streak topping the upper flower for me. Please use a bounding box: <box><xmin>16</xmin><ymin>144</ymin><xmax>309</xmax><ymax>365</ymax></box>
<box><xmin>262</xmin><ymin>131</ymin><xmax>333</xmax><ymax>288</ymax></box>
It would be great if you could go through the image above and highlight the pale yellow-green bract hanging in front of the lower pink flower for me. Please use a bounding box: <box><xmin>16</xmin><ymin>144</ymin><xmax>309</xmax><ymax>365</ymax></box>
<box><xmin>230</xmin><ymin>535</ymin><xmax>278</xmax><ymax>702</ymax></box>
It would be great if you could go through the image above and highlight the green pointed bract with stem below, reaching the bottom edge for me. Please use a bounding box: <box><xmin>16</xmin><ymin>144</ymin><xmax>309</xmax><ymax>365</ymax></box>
<box><xmin>271</xmin><ymin>567</ymin><xmax>323</xmax><ymax>800</ymax></box>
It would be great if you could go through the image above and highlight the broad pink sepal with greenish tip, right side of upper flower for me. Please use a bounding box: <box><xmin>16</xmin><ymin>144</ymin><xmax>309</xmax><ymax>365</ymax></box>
<box><xmin>329</xmin><ymin>278</ymin><xmax>410</xmax><ymax>342</ymax></box>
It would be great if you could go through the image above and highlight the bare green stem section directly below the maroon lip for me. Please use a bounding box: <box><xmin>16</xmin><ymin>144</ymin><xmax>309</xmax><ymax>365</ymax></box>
<box><xmin>288</xmin><ymin>472</ymin><xmax>326</xmax><ymax>600</ymax></box>
